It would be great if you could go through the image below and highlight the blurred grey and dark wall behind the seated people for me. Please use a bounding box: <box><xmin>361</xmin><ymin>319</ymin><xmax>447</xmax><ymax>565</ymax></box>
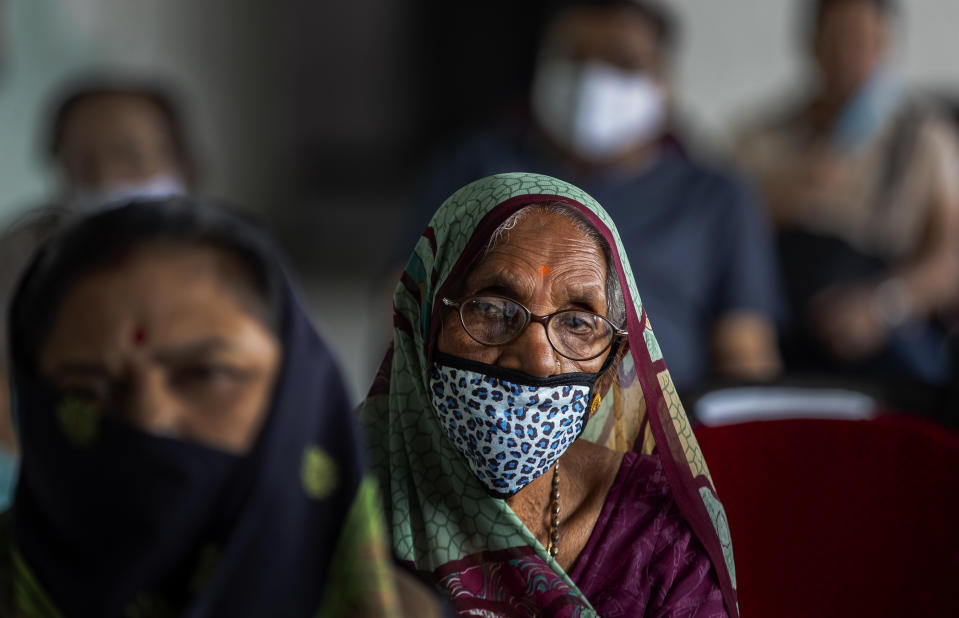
<box><xmin>0</xmin><ymin>0</ymin><xmax>959</xmax><ymax>396</ymax></box>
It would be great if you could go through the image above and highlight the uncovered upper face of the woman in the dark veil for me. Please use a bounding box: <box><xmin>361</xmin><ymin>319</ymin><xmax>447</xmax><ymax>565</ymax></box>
<box><xmin>40</xmin><ymin>245</ymin><xmax>280</xmax><ymax>453</ymax></box>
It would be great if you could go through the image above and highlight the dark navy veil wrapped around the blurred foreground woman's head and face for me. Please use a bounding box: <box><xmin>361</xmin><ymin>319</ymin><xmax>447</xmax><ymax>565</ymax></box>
<box><xmin>4</xmin><ymin>198</ymin><xmax>399</xmax><ymax>617</ymax></box>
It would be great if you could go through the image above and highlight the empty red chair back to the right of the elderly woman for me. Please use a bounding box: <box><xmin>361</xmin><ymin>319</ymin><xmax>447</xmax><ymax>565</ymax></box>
<box><xmin>696</xmin><ymin>416</ymin><xmax>959</xmax><ymax>618</ymax></box>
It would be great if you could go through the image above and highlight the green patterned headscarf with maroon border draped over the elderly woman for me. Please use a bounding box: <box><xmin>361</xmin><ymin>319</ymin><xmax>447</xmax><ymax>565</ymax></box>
<box><xmin>361</xmin><ymin>173</ymin><xmax>738</xmax><ymax>616</ymax></box>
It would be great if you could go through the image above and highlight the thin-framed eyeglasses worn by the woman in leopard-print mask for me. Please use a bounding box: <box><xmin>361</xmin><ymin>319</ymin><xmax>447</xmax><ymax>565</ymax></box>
<box><xmin>443</xmin><ymin>296</ymin><xmax>627</xmax><ymax>361</ymax></box>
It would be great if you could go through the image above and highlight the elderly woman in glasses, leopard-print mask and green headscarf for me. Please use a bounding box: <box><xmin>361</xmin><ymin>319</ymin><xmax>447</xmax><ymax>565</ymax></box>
<box><xmin>362</xmin><ymin>174</ymin><xmax>738</xmax><ymax>618</ymax></box>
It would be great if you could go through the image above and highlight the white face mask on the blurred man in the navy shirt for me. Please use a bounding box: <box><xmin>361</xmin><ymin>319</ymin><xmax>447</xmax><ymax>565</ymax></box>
<box><xmin>532</xmin><ymin>60</ymin><xmax>666</xmax><ymax>162</ymax></box>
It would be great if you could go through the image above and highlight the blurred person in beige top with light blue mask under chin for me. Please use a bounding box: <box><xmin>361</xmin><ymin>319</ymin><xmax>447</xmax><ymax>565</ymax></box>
<box><xmin>738</xmin><ymin>0</ymin><xmax>959</xmax><ymax>382</ymax></box>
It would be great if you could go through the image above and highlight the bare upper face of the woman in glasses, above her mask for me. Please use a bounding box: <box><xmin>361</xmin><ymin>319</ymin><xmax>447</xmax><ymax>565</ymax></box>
<box><xmin>437</xmin><ymin>211</ymin><xmax>608</xmax><ymax>377</ymax></box>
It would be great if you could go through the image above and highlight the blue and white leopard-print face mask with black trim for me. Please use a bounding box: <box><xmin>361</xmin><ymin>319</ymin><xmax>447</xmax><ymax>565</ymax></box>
<box><xmin>429</xmin><ymin>353</ymin><xmax>605</xmax><ymax>498</ymax></box>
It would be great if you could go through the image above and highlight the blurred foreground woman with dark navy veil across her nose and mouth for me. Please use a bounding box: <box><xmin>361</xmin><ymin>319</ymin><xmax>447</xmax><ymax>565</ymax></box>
<box><xmin>0</xmin><ymin>199</ymin><xmax>432</xmax><ymax>617</ymax></box>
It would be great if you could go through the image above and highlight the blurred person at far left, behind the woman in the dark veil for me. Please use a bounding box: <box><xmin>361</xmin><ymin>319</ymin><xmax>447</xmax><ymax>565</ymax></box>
<box><xmin>0</xmin><ymin>79</ymin><xmax>194</xmax><ymax>509</ymax></box>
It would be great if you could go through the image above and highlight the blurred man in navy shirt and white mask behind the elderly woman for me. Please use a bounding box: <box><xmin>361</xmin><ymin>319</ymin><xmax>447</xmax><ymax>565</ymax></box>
<box><xmin>404</xmin><ymin>0</ymin><xmax>782</xmax><ymax>389</ymax></box>
